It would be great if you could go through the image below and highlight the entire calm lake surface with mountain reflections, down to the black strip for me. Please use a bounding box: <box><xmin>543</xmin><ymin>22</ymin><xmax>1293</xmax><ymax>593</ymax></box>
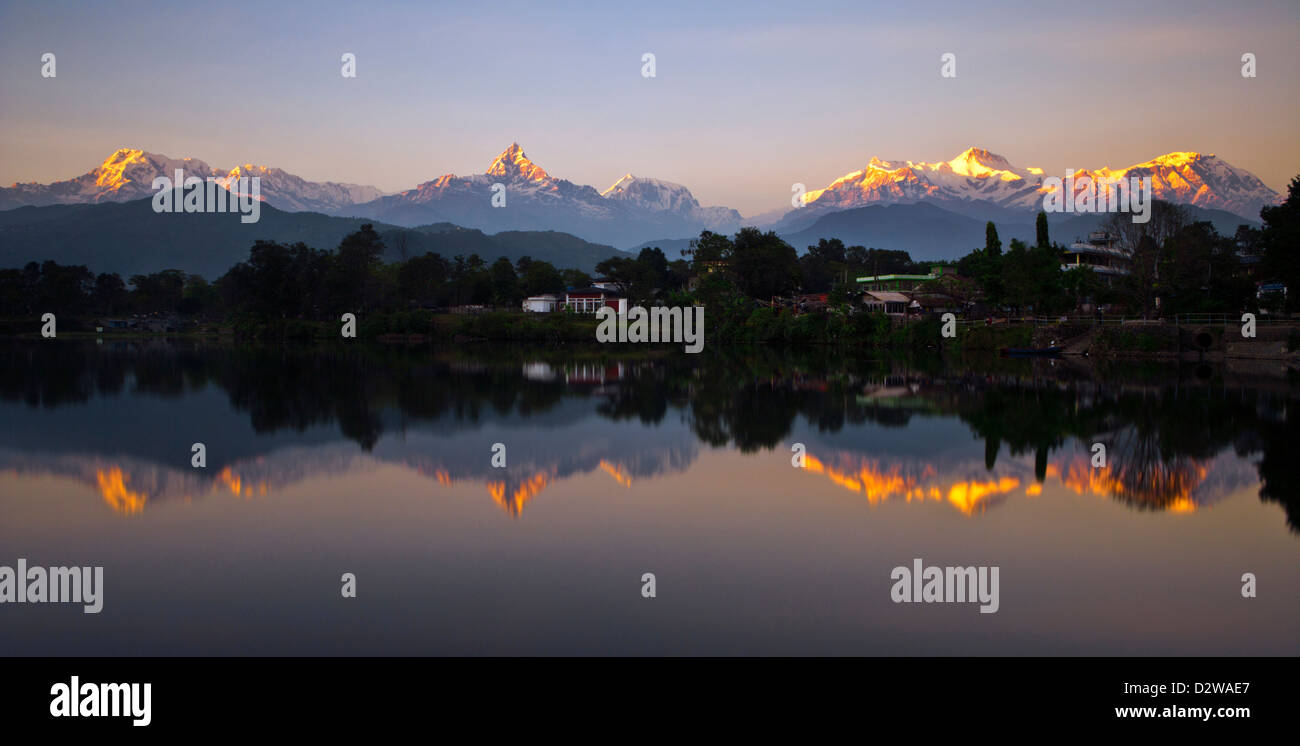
<box><xmin>0</xmin><ymin>341</ymin><xmax>1300</xmax><ymax>655</ymax></box>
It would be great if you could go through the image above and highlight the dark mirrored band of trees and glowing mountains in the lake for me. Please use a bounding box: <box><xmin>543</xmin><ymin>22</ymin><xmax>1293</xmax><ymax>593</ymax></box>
<box><xmin>0</xmin><ymin>341</ymin><xmax>1300</xmax><ymax>532</ymax></box>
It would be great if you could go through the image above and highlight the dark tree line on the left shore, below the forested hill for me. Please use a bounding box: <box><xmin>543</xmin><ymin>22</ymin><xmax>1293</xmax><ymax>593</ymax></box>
<box><xmin>0</xmin><ymin>225</ymin><xmax>592</xmax><ymax>318</ymax></box>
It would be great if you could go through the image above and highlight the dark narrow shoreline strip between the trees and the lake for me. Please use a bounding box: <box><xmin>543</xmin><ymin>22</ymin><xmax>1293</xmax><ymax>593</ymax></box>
<box><xmin>0</xmin><ymin>312</ymin><xmax>1300</xmax><ymax>368</ymax></box>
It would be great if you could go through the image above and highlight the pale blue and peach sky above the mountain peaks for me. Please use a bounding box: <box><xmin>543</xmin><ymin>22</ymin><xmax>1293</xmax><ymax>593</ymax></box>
<box><xmin>0</xmin><ymin>0</ymin><xmax>1300</xmax><ymax>216</ymax></box>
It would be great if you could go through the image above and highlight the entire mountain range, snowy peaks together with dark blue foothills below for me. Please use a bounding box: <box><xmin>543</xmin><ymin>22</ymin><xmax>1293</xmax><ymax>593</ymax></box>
<box><xmin>0</xmin><ymin>143</ymin><xmax>1281</xmax><ymax>276</ymax></box>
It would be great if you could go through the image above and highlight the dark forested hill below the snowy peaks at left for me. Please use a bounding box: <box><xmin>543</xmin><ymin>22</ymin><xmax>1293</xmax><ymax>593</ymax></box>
<box><xmin>0</xmin><ymin>199</ymin><xmax>625</xmax><ymax>279</ymax></box>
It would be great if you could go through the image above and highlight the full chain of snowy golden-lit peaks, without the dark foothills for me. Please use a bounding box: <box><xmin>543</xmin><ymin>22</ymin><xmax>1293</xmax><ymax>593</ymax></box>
<box><xmin>0</xmin><ymin>143</ymin><xmax>1281</xmax><ymax>247</ymax></box>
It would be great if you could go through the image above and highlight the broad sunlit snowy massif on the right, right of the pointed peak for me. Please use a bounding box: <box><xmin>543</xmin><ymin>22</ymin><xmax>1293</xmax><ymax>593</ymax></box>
<box><xmin>781</xmin><ymin>148</ymin><xmax>1281</xmax><ymax>226</ymax></box>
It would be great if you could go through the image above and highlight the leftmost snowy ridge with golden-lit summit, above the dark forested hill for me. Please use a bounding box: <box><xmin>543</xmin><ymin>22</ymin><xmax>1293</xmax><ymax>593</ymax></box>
<box><xmin>0</xmin><ymin>148</ymin><xmax>384</xmax><ymax>212</ymax></box>
